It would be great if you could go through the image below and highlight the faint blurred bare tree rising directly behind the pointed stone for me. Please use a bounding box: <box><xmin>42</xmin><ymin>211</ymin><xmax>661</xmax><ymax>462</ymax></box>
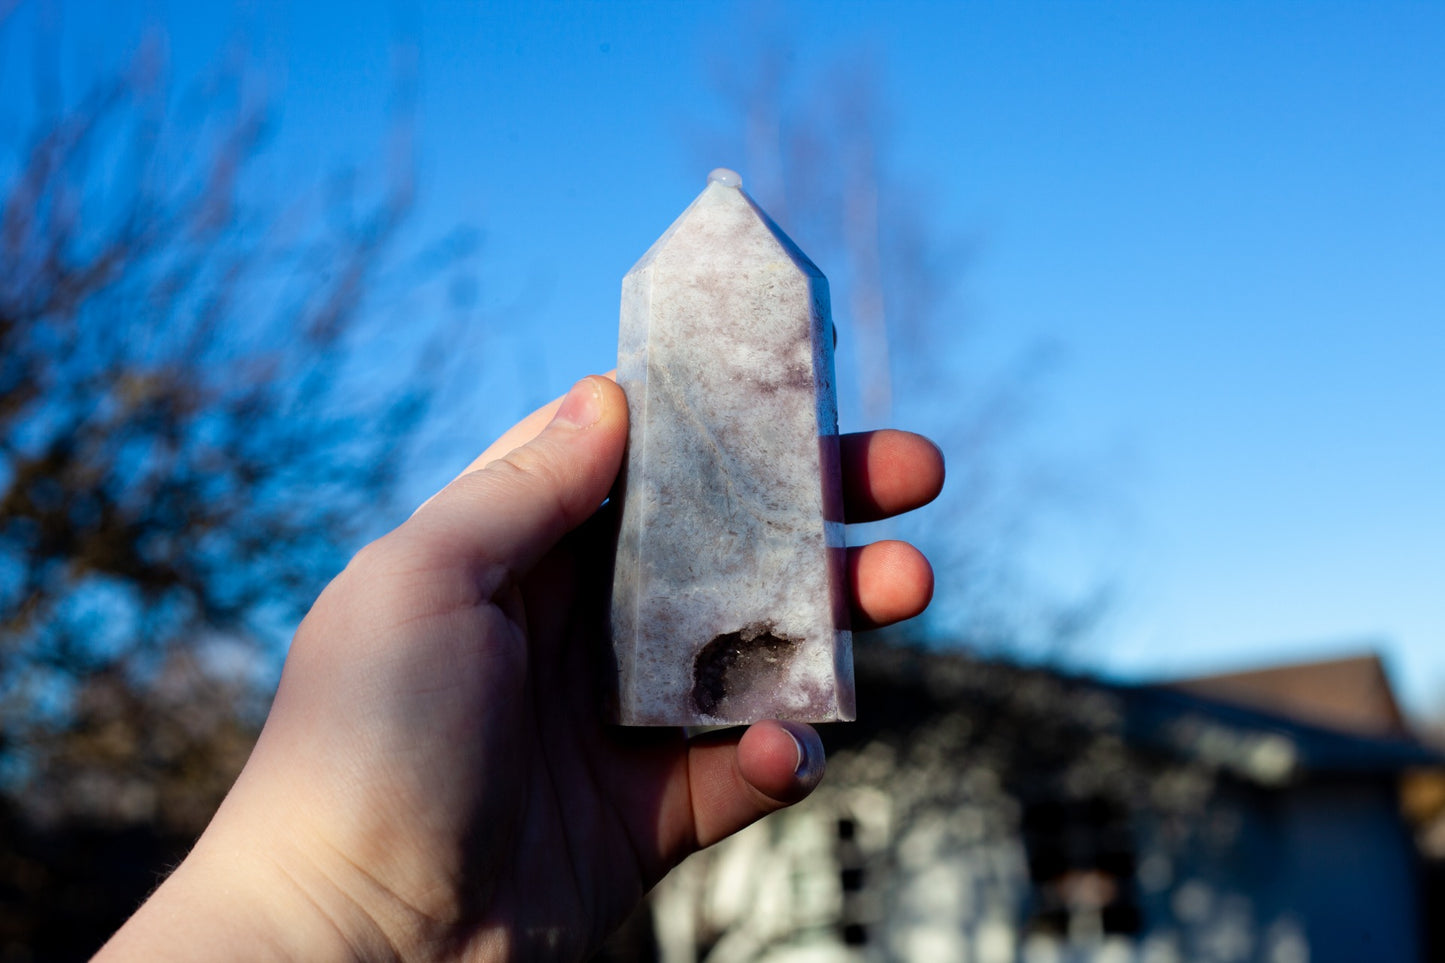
<box><xmin>699</xmin><ymin>31</ymin><xmax>1107</xmax><ymax>654</ymax></box>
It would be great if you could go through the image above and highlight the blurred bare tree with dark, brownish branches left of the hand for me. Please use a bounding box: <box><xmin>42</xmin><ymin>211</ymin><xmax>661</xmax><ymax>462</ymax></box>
<box><xmin>0</xmin><ymin>15</ymin><xmax>467</xmax><ymax>956</ymax></box>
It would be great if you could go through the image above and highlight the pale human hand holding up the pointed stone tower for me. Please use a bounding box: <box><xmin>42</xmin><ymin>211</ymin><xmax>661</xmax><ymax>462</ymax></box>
<box><xmin>105</xmin><ymin>377</ymin><xmax>944</xmax><ymax>960</ymax></box>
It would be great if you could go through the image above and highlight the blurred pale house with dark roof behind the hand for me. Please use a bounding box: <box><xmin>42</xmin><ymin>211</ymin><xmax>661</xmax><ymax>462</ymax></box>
<box><xmin>638</xmin><ymin>646</ymin><xmax>1445</xmax><ymax>963</ymax></box>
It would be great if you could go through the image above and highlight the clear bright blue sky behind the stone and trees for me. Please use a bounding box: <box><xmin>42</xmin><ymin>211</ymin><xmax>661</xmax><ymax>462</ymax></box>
<box><xmin>11</xmin><ymin>0</ymin><xmax>1445</xmax><ymax>710</ymax></box>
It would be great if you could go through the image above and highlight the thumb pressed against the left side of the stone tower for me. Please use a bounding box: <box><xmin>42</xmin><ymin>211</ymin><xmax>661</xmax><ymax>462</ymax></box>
<box><xmin>406</xmin><ymin>375</ymin><xmax>627</xmax><ymax>574</ymax></box>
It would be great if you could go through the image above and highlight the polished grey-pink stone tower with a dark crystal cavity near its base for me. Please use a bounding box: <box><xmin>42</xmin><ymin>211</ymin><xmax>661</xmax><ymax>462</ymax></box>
<box><xmin>611</xmin><ymin>171</ymin><xmax>854</xmax><ymax>726</ymax></box>
